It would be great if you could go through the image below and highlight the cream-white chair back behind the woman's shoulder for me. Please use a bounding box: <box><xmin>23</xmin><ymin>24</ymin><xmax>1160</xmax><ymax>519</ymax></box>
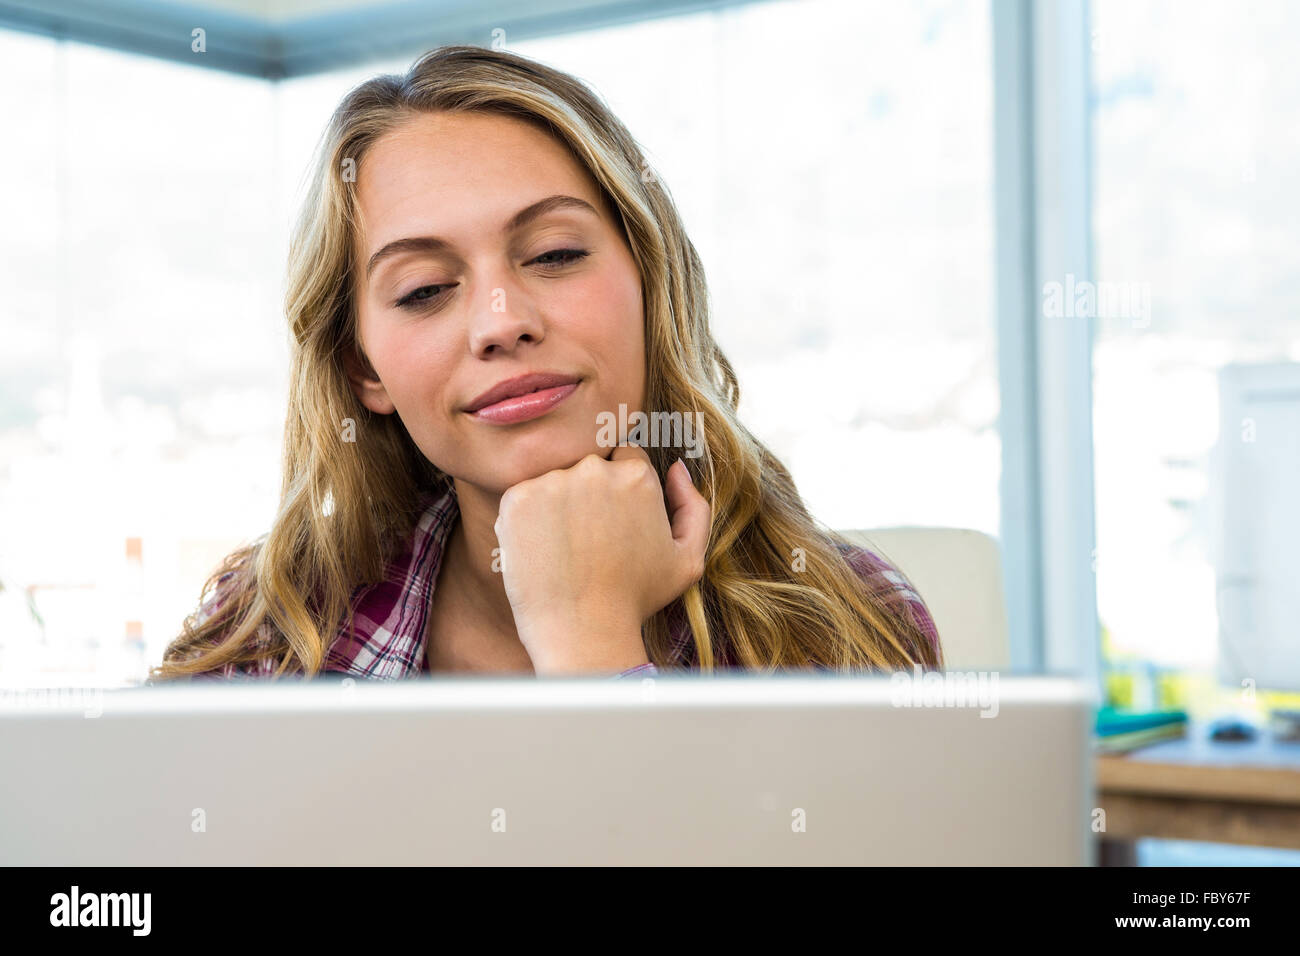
<box><xmin>840</xmin><ymin>528</ymin><xmax>1011</xmax><ymax>671</ymax></box>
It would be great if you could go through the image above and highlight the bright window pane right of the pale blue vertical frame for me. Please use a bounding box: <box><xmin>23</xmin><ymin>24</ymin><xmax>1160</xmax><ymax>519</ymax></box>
<box><xmin>1093</xmin><ymin>0</ymin><xmax>1300</xmax><ymax>689</ymax></box>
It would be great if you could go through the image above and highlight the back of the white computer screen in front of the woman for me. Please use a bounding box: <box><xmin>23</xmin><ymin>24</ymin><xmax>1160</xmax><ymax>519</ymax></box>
<box><xmin>0</xmin><ymin>675</ymin><xmax>1095</xmax><ymax>866</ymax></box>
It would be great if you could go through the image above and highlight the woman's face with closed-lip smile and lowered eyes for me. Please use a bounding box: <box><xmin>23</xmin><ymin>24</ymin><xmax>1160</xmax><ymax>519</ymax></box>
<box><xmin>348</xmin><ymin>113</ymin><xmax>645</xmax><ymax>493</ymax></box>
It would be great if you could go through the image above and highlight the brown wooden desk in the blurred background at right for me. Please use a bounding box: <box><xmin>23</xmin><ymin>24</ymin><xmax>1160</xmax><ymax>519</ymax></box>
<box><xmin>1096</xmin><ymin>723</ymin><xmax>1300</xmax><ymax>866</ymax></box>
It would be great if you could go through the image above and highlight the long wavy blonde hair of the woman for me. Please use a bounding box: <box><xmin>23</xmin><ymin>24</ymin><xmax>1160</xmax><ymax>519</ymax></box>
<box><xmin>148</xmin><ymin>46</ymin><xmax>943</xmax><ymax>684</ymax></box>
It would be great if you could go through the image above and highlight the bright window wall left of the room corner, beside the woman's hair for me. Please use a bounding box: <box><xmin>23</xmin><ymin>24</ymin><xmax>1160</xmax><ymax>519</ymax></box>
<box><xmin>0</xmin><ymin>33</ymin><xmax>285</xmax><ymax>685</ymax></box>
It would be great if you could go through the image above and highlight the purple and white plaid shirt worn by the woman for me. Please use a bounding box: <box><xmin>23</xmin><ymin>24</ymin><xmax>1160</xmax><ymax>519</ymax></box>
<box><xmin>198</xmin><ymin>488</ymin><xmax>939</xmax><ymax>680</ymax></box>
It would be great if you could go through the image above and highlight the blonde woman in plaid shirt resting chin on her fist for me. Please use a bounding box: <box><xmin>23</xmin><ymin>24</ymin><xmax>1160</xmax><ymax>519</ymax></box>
<box><xmin>150</xmin><ymin>47</ymin><xmax>941</xmax><ymax>683</ymax></box>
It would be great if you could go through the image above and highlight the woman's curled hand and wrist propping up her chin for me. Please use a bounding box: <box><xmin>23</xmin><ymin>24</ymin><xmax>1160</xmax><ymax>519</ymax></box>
<box><xmin>495</xmin><ymin>445</ymin><xmax>711</xmax><ymax>675</ymax></box>
